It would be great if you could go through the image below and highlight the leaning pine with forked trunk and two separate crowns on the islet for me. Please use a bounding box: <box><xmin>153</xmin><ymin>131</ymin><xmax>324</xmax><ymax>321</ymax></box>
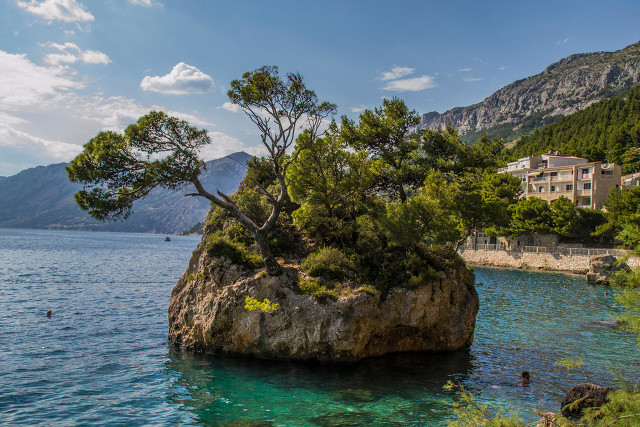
<box><xmin>67</xmin><ymin>66</ymin><xmax>335</xmax><ymax>275</ymax></box>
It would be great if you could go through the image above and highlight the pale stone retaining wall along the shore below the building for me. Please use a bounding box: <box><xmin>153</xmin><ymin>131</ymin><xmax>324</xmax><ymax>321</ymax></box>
<box><xmin>460</xmin><ymin>249</ymin><xmax>640</xmax><ymax>274</ymax></box>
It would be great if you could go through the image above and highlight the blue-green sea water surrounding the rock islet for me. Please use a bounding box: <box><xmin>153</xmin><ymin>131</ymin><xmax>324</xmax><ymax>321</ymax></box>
<box><xmin>0</xmin><ymin>229</ymin><xmax>640</xmax><ymax>426</ymax></box>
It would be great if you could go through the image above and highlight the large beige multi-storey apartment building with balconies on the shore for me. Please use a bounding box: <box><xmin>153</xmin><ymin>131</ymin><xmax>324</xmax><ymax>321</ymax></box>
<box><xmin>498</xmin><ymin>151</ymin><xmax>621</xmax><ymax>209</ymax></box>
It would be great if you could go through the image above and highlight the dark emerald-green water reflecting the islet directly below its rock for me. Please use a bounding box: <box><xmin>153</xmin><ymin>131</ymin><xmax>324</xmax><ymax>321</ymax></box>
<box><xmin>167</xmin><ymin>349</ymin><xmax>473</xmax><ymax>426</ymax></box>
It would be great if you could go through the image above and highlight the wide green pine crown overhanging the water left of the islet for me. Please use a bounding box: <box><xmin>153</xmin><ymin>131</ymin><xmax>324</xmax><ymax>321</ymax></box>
<box><xmin>67</xmin><ymin>111</ymin><xmax>210</xmax><ymax>221</ymax></box>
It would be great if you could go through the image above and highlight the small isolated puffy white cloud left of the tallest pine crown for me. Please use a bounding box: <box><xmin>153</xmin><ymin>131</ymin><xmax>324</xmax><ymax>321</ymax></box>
<box><xmin>140</xmin><ymin>62</ymin><xmax>215</xmax><ymax>95</ymax></box>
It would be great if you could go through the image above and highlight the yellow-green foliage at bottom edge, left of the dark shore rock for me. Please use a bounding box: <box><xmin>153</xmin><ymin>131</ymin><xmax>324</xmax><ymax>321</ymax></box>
<box><xmin>444</xmin><ymin>381</ymin><xmax>524</xmax><ymax>427</ymax></box>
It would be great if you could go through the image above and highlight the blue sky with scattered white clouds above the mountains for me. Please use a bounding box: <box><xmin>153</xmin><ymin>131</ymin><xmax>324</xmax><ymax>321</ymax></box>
<box><xmin>0</xmin><ymin>0</ymin><xmax>640</xmax><ymax>176</ymax></box>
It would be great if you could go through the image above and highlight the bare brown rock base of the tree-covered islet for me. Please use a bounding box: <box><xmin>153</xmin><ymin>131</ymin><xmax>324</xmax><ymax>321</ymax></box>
<box><xmin>169</xmin><ymin>236</ymin><xmax>478</xmax><ymax>362</ymax></box>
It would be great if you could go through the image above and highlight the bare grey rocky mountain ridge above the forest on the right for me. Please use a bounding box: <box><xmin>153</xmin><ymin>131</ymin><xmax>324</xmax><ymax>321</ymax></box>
<box><xmin>420</xmin><ymin>42</ymin><xmax>640</xmax><ymax>142</ymax></box>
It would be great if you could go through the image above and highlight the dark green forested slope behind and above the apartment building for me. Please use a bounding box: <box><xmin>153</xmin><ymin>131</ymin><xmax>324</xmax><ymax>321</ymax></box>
<box><xmin>507</xmin><ymin>86</ymin><xmax>640</xmax><ymax>173</ymax></box>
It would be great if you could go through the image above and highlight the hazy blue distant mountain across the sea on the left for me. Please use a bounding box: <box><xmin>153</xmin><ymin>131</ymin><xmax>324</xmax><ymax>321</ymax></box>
<box><xmin>0</xmin><ymin>152</ymin><xmax>252</xmax><ymax>234</ymax></box>
